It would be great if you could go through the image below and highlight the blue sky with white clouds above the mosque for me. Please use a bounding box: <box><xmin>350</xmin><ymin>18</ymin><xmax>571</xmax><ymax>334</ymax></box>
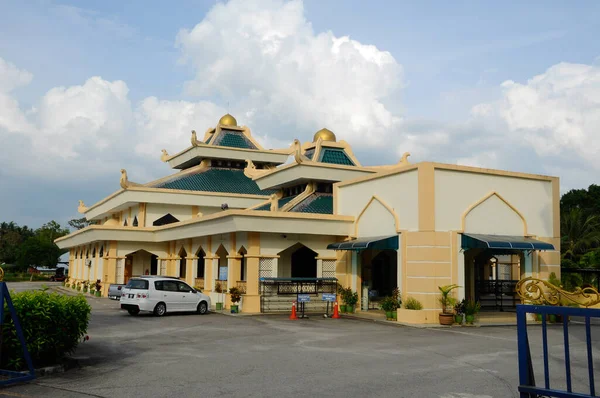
<box><xmin>0</xmin><ymin>0</ymin><xmax>600</xmax><ymax>227</ymax></box>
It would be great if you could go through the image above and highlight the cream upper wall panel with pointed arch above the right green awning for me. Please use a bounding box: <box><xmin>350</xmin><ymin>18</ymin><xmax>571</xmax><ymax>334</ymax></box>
<box><xmin>435</xmin><ymin>169</ymin><xmax>554</xmax><ymax>237</ymax></box>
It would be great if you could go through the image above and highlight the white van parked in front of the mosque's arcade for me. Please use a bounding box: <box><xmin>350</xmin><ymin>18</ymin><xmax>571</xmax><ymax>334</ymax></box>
<box><xmin>121</xmin><ymin>276</ymin><xmax>210</xmax><ymax>316</ymax></box>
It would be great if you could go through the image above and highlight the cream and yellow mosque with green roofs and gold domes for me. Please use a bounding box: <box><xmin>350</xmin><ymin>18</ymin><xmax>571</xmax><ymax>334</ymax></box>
<box><xmin>56</xmin><ymin>115</ymin><xmax>560</xmax><ymax>323</ymax></box>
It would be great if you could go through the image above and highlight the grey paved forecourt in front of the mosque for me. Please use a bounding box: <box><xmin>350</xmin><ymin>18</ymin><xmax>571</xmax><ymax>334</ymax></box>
<box><xmin>0</xmin><ymin>282</ymin><xmax>600</xmax><ymax>398</ymax></box>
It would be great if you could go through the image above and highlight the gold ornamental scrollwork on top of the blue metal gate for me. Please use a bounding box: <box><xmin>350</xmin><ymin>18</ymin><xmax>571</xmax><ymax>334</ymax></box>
<box><xmin>515</xmin><ymin>277</ymin><xmax>600</xmax><ymax>307</ymax></box>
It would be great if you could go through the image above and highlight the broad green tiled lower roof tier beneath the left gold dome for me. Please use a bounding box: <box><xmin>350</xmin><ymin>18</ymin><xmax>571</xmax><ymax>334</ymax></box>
<box><xmin>156</xmin><ymin>167</ymin><xmax>275</xmax><ymax>195</ymax></box>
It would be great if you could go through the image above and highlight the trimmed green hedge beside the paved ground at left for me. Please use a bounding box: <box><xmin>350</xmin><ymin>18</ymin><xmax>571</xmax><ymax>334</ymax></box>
<box><xmin>0</xmin><ymin>291</ymin><xmax>92</xmax><ymax>370</ymax></box>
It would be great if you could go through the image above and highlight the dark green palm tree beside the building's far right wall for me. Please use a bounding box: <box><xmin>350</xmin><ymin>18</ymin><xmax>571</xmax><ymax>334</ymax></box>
<box><xmin>560</xmin><ymin>208</ymin><xmax>600</xmax><ymax>263</ymax></box>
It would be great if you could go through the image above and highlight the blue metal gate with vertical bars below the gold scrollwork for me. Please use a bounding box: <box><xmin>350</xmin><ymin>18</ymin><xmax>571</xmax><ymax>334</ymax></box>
<box><xmin>517</xmin><ymin>304</ymin><xmax>600</xmax><ymax>398</ymax></box>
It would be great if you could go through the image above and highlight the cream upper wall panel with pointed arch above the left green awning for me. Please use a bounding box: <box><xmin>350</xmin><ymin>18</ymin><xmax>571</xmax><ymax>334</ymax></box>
<box><xmin>336</xmin><ymin>170</ymin><xmax>419</xmax><ymax>232</ymax></box>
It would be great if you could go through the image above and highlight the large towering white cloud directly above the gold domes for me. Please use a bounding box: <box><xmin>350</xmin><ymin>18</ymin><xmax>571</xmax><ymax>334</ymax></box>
<box><xmin>177</xmin><ymin>0</ymin><xmax>402</xmax><ymax>143</ymax></box>
